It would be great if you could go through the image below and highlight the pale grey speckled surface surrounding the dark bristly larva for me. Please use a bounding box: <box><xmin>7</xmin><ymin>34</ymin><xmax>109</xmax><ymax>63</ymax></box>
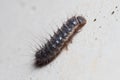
<box><xmin>0</xmin><ymin>0</ymin><xmax>120</xmax><ymax>80</ymax></box>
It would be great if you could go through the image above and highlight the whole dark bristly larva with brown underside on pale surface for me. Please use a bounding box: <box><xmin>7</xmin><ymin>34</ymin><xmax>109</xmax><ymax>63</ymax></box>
<box><xmin>35</xmin><ymin>16</ymin><xmax>86</xmax><ymax>67</ymax></box>
